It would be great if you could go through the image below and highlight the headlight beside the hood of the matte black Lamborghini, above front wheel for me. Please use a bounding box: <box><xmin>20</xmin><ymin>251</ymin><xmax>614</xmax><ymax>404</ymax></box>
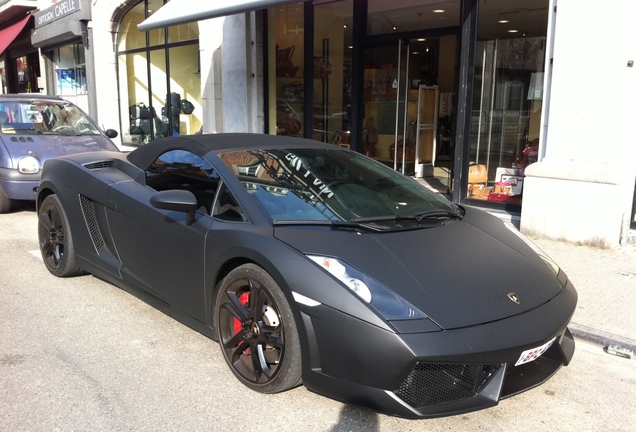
<box><xmin>307</xmin><ymin>255</ymin><xmax>428</xmax><ymax>320</ymax></box>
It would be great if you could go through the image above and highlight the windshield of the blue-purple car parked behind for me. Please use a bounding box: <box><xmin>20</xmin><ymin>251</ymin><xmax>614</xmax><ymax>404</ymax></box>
<box><xmin>0</xmin><ymin>99</ymin><xmax>100</xmax><ymax>135</ymax></box>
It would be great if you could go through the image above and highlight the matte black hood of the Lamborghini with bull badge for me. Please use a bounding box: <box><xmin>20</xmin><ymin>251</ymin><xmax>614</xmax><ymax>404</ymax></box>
<box><xmin>275</xmin><ymin>210</ymin><xmax>562</xmax><ymax>329</ymax></box>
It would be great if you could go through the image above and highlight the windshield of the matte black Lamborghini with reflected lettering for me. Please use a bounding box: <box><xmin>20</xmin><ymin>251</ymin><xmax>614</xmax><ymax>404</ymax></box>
<box><xmin>219</xmin><ymin>148</ymin><xmax>459</xmax><ymax>225</ymax></box>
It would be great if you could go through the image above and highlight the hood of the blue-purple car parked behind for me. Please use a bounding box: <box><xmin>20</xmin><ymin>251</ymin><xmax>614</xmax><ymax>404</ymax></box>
<box><xmin>0</xmin><ymin>134</ymin><xmax>117</xmax><ymax>167</ymax></box>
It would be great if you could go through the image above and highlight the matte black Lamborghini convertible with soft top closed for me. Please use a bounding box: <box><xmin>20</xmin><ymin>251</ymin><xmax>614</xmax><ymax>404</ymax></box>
<box><xmin>37</xmin><ymin>134</ymin><xmax>577</xmax><ymax>418</ymax></box>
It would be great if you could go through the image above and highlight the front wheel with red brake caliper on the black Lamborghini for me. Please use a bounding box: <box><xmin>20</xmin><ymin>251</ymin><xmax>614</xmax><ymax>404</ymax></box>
<box><xmin>215</xmin><ymin>264</ymin><xmax>302</xmax><ymax>393</ymax></box>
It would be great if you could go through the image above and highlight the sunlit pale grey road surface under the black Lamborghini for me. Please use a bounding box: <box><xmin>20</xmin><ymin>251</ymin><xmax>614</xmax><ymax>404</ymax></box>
<box><xmin>0</xmin><ymin>205</ymin><xmax>636</xmax><ymax>432</ymax></box>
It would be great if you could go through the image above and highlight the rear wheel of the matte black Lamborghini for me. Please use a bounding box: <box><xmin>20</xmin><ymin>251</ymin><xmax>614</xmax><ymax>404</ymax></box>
<box><xmin>38</xmin><ymin>195</ymin><xmax>84</xmax><ymax>277</ymax></box>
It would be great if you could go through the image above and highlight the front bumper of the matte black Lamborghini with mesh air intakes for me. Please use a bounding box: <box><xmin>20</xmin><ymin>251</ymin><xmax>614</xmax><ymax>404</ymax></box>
<box><xmin>301</xmin><ymin>283</ymin><xmax>577</xmax><ymax>418</ymax></box>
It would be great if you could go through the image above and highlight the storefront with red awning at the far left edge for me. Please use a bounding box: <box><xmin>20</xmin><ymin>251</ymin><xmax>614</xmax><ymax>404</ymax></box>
<box><xmin>0</xmin><ymin>0</ymin><xmax>40</xmax><ymax>93</ymax></box>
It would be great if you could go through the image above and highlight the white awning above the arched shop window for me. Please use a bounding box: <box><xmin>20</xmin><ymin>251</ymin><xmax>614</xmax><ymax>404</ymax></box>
<box><xmin>137</xmin><ymin>0</ymin><xmax>299</xmax><ymax>31</ymax></box>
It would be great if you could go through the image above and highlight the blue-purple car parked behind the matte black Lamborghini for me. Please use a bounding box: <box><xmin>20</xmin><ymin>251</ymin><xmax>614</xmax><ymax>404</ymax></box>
<box><xmin>0</xmin><ymin>93</ymin><xmax>117</xmax><ymax>213</ymax></box>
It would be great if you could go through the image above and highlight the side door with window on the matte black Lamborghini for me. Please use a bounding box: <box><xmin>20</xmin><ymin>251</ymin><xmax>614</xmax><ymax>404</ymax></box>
<box><xmin>108</xmin><ymin>150</ymin><xmax>219</xmax><ymax>321</ymax></box>
